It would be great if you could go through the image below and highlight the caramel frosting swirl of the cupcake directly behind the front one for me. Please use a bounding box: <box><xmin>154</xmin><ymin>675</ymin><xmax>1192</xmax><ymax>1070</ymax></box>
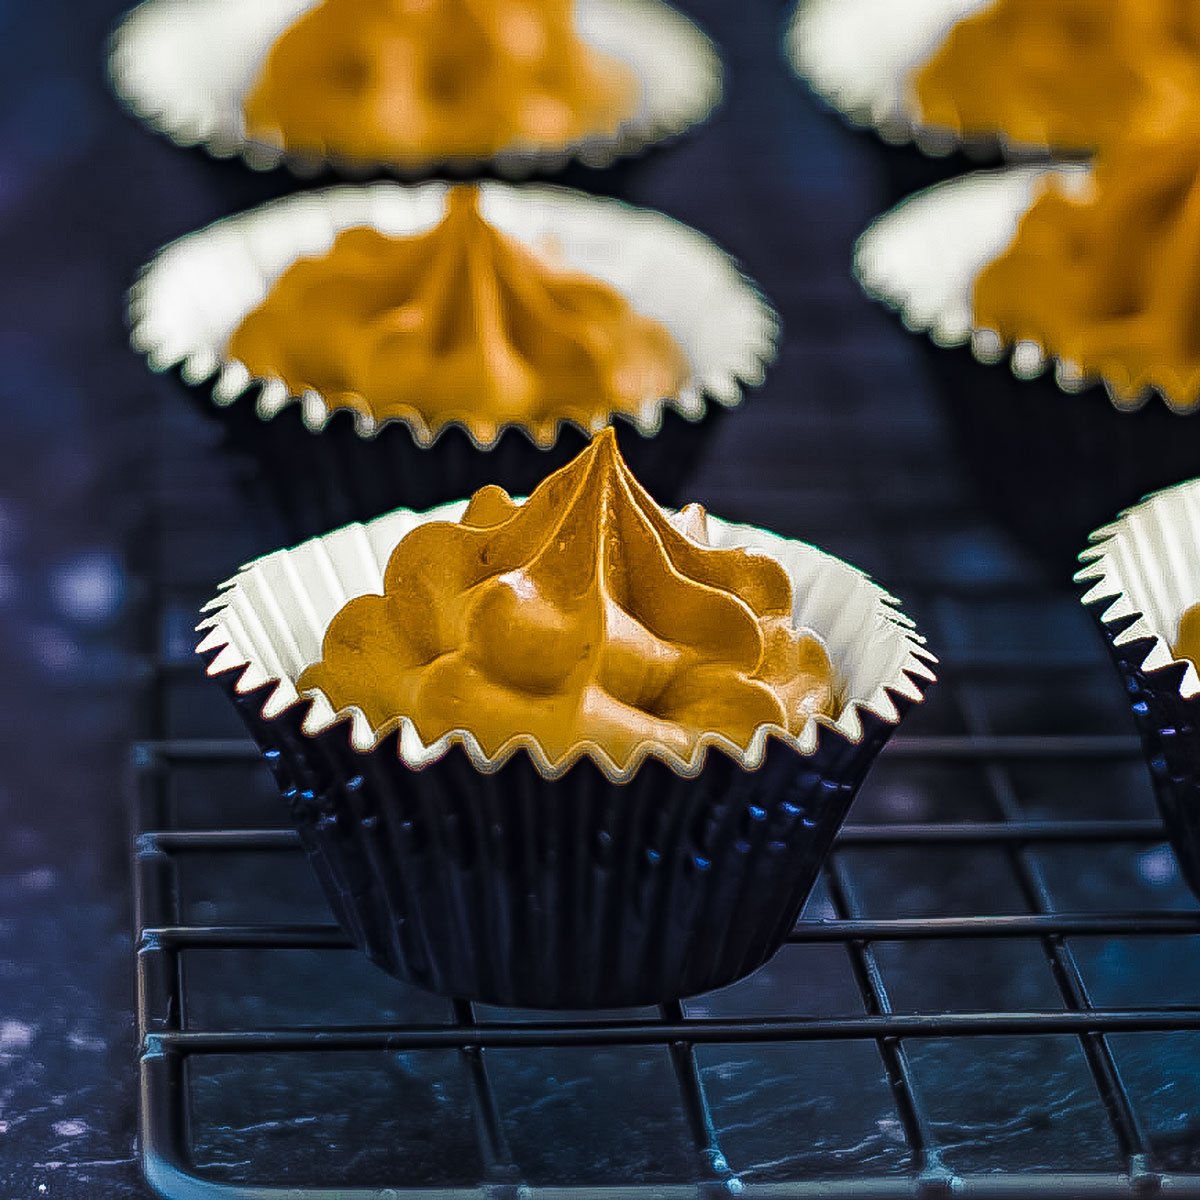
<box><xmin>228</xmin><ymin>186</ymin><xmax>690</xmax><ymax>444</ymax></box>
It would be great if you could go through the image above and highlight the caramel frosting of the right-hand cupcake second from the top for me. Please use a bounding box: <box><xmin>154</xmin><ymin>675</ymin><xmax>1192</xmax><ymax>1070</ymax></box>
<box><xmin>974</xmin><ymin>132</ymin><xmax>1200</xmax><ymax>409</ymax></box>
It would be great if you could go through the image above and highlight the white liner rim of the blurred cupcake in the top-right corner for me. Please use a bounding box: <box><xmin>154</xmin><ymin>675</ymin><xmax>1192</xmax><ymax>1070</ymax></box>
<box><xmin>785</xmin><ymin>0</ymin><xmax>1070</xmax><ymax>158</ymax></box>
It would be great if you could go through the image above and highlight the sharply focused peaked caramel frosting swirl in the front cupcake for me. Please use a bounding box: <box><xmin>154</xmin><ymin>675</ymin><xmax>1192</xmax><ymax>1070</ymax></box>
<box><xmin>298</xmin><ymin>427</ymin><xmax>834</xmax><ymax>769</ymax></box>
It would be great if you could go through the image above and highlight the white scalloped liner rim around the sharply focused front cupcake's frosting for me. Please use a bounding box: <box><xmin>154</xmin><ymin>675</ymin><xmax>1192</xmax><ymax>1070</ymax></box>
<box><xmin>196</xmin><ymin>500</ymin><xmax>937</xmax><ymax>784</ymax></box>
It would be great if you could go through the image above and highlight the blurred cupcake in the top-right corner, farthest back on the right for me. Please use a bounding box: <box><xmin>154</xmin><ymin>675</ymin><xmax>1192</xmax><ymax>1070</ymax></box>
<box><xmin>788</xmin><ymin>0</ymin><xmax>1200</xmax><ymax>196</ymax></box>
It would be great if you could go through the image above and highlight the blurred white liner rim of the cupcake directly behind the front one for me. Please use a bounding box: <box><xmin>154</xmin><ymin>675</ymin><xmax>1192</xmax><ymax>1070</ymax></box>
<box><xmin>130</xmin><ymin>181</ymin><xmax>779</xmax><ymax>450</ymax></box>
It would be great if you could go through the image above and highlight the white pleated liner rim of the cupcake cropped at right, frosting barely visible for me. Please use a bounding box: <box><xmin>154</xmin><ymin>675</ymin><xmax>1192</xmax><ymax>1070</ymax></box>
<box><xmin>1075</xmin><ymin>480</ymin><xmax>1200</xmax><ymax>700</ymax></box>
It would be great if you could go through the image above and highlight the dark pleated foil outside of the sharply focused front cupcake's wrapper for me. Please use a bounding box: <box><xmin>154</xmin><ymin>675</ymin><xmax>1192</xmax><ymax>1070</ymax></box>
<box><xmin>206</xmin><ymin>652</ymin><xmax>928</xmax><ymax>1008</ymax></box>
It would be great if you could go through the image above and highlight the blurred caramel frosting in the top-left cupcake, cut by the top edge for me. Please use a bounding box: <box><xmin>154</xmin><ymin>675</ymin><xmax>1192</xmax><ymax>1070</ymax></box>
<box><xmin>244</xmin><ymin>0</ymin><xmax>640</xmax><ymax>167</ymax></box>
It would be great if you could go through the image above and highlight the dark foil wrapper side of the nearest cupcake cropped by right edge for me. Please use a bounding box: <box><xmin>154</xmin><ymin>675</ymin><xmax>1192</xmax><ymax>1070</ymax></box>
<box><xmin>1086</xmin><ymin>595</ymin><xmax>1200</xmax><ymax>898</ymax></box>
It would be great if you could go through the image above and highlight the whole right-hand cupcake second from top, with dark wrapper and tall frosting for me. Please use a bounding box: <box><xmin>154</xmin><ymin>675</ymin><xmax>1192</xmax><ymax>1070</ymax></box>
<box><xmin>856</xmin><ymin>138</ymin><xmax>1200</xmax><ymax>571</ymax></box>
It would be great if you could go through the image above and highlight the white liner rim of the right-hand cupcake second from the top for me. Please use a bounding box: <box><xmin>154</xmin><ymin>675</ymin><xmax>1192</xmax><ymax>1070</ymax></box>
<box><xmin>854</xmin><ymin>164</ymin><xmax>1195</xmax><ymax>413</ymax></box>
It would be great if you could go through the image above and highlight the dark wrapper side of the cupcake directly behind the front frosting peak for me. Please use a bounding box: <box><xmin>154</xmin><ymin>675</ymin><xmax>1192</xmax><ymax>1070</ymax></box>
<box><xmin>184</xmin><ymin>369</ymin><xmax>726</xmax><ymax>541</ymax></box>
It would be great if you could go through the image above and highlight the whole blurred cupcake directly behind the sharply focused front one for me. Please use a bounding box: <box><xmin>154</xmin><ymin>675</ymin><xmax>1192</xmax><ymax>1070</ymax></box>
<box><xmin>131</xmin><ymin>184</ymin><xmax>778</xmax><ymax>538</ymax></box>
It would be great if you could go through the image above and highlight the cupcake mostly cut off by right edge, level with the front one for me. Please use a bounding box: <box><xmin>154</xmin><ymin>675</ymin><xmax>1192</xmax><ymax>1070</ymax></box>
<box><xmin>1075</xmin><ymin>480</ymin><xmax>1200</xmax><ymax>896</ymax></box>
